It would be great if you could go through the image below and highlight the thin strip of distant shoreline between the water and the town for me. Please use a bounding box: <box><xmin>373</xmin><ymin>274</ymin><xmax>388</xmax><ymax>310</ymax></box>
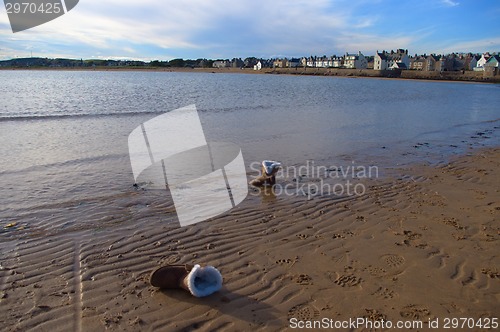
<box><xmin>0</xmin><ymin>66</ymin><xmax>500</xmax><ymax>83</ymax></box>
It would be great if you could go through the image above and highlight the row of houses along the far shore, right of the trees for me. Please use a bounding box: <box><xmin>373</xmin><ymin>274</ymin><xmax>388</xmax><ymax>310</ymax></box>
<box><xmin>229</xmin><ymin>49</ymin><xmax>500</xmax><ymax>71</ymax></box>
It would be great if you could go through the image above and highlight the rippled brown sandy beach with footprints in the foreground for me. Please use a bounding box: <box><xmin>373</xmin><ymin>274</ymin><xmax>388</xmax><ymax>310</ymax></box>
<box><xmin>0</xmin><ymin>148</ymin><xmax>500</xmax><ymax>331</ymax></box>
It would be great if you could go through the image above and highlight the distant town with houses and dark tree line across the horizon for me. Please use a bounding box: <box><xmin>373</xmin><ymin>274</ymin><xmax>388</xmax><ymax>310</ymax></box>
<box><xmin>0</xmin><ymin>49</ymin><xmax>500</xmax><ymax>81</ymax></box>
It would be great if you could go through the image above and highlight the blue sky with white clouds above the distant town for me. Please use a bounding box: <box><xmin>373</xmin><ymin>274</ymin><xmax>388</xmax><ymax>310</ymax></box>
<box><xmin>0</xmin><ymin>0</ymin><xmax>500</xmax><ymax>61</ymax></box>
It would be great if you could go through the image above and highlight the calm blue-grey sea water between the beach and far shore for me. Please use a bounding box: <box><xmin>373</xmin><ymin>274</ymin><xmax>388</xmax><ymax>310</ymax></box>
<box><xmin>0</xmin><ymin>70</ymin><xmax>500</xmax><ymax>235</ymax></box>
